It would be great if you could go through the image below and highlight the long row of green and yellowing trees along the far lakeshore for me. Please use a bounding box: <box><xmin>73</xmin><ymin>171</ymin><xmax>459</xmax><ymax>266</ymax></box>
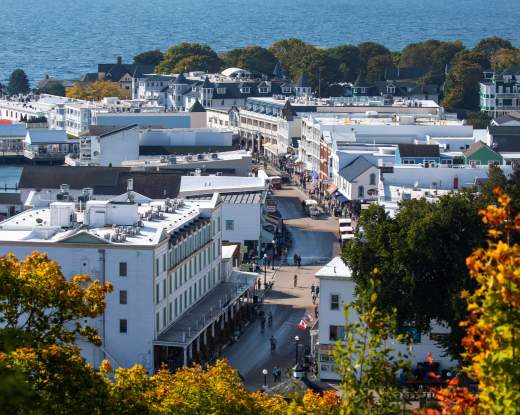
<box><xmin>134</xmin><ymin>37</ymin><xmax>520</xmax><ymax>112</ymax></box>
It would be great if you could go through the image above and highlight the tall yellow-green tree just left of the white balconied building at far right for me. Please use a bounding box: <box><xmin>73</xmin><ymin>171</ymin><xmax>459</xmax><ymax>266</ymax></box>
<box><xmin>442</xmin><ymin>60</ymin><xmax>483</xmax><ymax>111</ymax></box>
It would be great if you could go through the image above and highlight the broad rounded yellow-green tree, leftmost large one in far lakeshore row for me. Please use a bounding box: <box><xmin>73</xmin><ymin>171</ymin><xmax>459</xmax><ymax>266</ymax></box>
<box><xmin>157</xmin><ymin>42</ymin><xmax>222</xmax><ymax>73</ymax></box>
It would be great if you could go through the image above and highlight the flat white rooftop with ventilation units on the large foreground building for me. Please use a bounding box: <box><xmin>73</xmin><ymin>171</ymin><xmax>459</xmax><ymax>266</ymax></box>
<box><xmin>0</xmin><ymin>191</ymin><xmax>218</xmax><ymax>246</ymax></box>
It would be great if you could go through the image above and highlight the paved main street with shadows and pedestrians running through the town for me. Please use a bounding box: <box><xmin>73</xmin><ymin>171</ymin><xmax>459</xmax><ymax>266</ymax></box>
<box><xmin>224</xmin><ymin>187</ymin><xmax>339</xmax><ymax>389</ymax></box>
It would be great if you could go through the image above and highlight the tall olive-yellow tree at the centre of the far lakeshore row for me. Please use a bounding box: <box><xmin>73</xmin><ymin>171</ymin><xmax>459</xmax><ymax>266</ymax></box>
<box><xmin>269</xmin><ymin>38</ymin><xmax>316</xmax><ymax>80</ymax></box>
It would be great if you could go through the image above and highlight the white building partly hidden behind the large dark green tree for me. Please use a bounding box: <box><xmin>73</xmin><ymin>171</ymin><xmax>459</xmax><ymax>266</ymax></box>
<box><xmin>311</xmin><ymin>257</ymin><xmax>455</xmax><ymax>381</ymax></box>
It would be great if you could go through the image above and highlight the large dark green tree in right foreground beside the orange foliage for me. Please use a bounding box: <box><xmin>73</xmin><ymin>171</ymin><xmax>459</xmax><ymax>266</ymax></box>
<box><xmin>343</xmin><ymin>192</ymin><xmax>485</xmax><ymax>358</ymax></box>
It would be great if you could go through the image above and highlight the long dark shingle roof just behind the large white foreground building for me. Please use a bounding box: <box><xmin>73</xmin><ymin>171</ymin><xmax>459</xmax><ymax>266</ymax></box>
<box><xmin>19</xmin><ymin>166</ymin><xmax>181</xmax><ymax>199</ymax></box>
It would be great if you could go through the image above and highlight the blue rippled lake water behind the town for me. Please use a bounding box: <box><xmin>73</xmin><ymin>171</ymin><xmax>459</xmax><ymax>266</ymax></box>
<box><xmin>0</xmin><ymin>0</ymin><xmax>520</xmax><ymax>83</ymax></box>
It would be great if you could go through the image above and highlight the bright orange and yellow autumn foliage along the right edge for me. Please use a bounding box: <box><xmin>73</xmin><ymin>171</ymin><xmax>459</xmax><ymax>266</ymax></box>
<box><xmin>416</xmin><ymin>188</ymin><xmax>520</xmax><ymax>415</ymax></box>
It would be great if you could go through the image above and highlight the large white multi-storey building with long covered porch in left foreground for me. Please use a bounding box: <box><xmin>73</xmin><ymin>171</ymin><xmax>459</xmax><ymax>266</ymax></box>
<box><xmin>0</xmin><ymin>187</ymin><xmax>254</xmax><ymax>373</ymax></box>
